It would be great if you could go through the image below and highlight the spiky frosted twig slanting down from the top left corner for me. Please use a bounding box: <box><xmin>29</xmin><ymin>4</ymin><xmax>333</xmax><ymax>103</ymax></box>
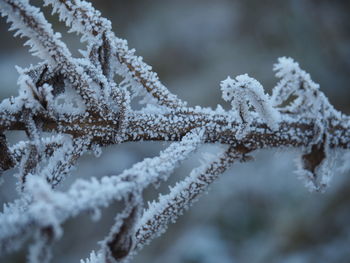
<box><xmin>0</xmin><ymin>0</ymin><xmax>98</xmax><ymax>107</ymax></box>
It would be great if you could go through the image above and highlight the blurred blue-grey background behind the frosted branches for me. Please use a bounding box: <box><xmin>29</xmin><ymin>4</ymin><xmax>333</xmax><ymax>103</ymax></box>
<box><xmin>0</xmin><ymin>0</ymin><xmax>350</xmax><ymax>263</ymax></box>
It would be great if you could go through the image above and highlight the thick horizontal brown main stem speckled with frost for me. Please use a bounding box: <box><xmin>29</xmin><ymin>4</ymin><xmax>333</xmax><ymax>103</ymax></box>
<box><xmin>0</xmin><ymin>110</ymin><xmax>350</xmax><ymax>149</ymax></box>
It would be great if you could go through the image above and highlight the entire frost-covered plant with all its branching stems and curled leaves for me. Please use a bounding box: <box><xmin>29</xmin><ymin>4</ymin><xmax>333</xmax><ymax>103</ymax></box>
<box><xmin>0</xmin><ymin>0</ymin><xmax>350</xmax><ymax>263</ymax></box>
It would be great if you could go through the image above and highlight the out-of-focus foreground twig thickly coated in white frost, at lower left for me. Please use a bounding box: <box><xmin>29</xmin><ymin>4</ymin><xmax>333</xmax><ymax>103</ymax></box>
<box><xmin>0</xmin><ymin>130</ymin><xmax>203</xmax><ymax>256</ymax></box>
